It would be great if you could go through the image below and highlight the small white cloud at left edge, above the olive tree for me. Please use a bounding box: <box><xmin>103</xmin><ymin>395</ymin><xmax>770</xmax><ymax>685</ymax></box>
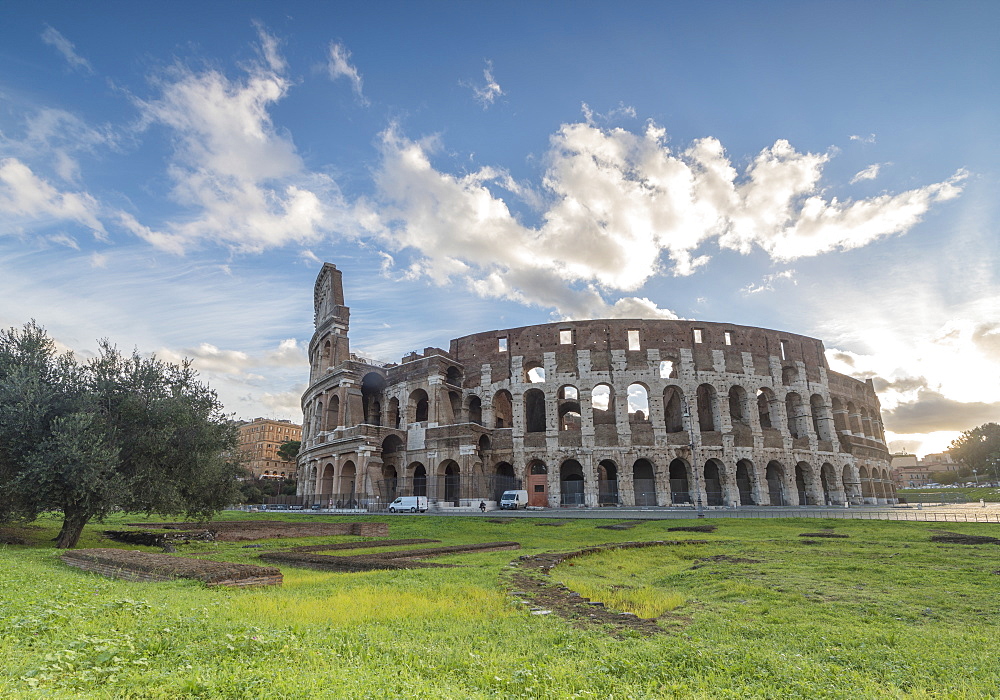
<box><xmin>0</xmin><ymin>158</ymin><xmax>107</xmax><ymax>238</ymax></box>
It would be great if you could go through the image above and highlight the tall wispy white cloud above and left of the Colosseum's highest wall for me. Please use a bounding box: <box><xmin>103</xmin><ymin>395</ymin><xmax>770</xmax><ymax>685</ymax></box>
<box><xmin>128</xmin><ymin>30</ymin><xmax>350</xmax><ymax>252</ymax></box>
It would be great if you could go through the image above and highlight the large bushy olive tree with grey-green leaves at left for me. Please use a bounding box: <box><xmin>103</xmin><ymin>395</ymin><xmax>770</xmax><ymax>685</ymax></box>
<box><xmin>0</xmin><ymin>321</ymin><xmax>241</xmax><ymax>547</ymax></box>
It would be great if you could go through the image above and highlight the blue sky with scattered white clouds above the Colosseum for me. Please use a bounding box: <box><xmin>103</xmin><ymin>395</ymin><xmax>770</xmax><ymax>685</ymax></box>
<box><xmin>0</xmin><ymin>0</ymin><xmax>1000</xmax><ymax>455</ymax></box>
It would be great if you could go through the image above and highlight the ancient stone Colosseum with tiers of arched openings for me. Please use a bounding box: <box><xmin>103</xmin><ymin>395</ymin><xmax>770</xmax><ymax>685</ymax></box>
<box><xmin>298</xmin><ymin>263</ymin><xmax>896</xmax><ymax>510</ymax></box>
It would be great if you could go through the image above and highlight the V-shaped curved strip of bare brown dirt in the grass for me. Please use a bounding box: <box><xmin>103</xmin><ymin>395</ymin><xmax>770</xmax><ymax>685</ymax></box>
<box><xmin>509</xmin><ymin>540</ymin><xmax>705</xmax><ymax>637</ymax></box>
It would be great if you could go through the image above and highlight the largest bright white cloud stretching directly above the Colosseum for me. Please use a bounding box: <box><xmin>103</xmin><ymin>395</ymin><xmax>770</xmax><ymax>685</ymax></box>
<box><xmin>359</xmin><ymin>123</ymin><xmax>965</xmax><ymax>316</ymax></box>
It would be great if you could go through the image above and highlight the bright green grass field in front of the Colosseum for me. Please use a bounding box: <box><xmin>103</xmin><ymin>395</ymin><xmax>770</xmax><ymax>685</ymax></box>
<box><xmin>0</xmin><ymin>514</ymin><xmax>1000</xmax><ymax>699</ymax></box>
